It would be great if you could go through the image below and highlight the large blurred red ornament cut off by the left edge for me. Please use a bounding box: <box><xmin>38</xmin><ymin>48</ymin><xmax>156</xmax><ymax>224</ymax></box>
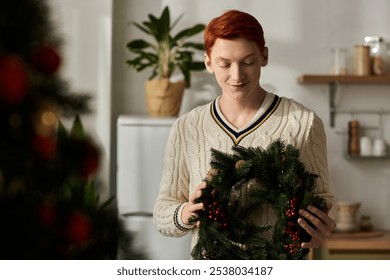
<box><xmin>0</xmin><ymin>54</ymin><xmax>28</xmax><ymax>104</ymax></box>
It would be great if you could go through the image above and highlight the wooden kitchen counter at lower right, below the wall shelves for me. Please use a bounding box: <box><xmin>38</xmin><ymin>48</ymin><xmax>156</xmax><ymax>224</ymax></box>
<box><xmin>312</xmin><ymin>231</ymin><xmax>390</xmax><ymax>260</ymax></box>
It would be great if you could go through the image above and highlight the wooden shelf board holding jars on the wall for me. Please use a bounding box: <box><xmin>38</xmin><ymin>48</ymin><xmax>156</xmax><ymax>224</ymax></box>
<box><xmin>298</xmin><ymin>74</ymin><xmax>390</xmax><ymax>85</ymax></box>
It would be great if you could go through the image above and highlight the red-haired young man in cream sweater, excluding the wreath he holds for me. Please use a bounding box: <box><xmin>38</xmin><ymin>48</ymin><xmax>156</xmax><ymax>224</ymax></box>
<box><xmin>154</xmin><ymin>10</ymin><xmax>336</xmax><ymax>258</ymax></box>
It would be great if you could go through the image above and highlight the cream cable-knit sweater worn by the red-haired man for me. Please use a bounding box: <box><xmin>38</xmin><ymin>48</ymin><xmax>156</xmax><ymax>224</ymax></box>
<box><xmin>153</xmin><ymin>93</ymin><xmax>335</xmax><ymax>256</ymax></box>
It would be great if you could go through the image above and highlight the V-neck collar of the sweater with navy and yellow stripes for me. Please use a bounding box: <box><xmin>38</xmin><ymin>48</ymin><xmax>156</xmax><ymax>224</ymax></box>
<box><xmin>210</xmin><ymin>92</ymin><xmax>281</xmax><ymax>145</ymax></box>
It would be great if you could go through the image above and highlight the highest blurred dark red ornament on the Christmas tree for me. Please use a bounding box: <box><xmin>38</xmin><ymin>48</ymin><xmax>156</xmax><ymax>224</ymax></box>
<box><xmin>31</xmin><ymin>46</ymin><xmax>61</xmax><ymax>75</ymax></box>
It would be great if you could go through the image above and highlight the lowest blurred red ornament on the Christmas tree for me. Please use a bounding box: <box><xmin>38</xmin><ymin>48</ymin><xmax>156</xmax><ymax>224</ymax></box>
<box><xmin>65</xmin><ymin>212</ymin><xmax>92</xmax><ymax>244</ymax></box>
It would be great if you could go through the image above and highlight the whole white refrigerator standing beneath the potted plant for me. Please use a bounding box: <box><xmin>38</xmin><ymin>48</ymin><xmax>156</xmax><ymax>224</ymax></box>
<box><xmin>116</xmin><ymin>115</ymin><xmax>191</xmax><ymax>260</ymax></box>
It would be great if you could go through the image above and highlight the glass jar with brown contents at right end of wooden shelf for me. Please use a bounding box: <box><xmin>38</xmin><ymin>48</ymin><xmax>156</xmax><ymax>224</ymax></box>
<box><xmin>364</xmin><ymin>36</ymin><xmax>386</xmax><ymax>76</ymax></box>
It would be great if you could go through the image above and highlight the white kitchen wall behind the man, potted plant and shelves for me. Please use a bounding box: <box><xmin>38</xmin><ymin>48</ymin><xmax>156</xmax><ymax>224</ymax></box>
<box><xmin>113</xmin><ymin>0</ymin><xmax>390</xmax><ymax>229</ymax></box>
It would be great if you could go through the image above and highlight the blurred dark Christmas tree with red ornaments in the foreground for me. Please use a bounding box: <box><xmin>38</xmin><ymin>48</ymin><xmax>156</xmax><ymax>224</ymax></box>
<box><xmin>0</xmin><ymin>0</ymin><xmax>141</xmax><ymax>259</ymax></box>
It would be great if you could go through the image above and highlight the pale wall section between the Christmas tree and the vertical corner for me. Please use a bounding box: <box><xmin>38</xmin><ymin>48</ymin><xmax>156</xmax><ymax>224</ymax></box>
<box><xmin>47</xmin><ymin>0</ymin><xmax>112</xmax><ymax>200</ymax></box>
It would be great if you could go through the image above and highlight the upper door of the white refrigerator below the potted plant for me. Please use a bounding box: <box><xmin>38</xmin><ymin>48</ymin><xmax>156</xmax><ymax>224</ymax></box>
<box><xmin>116</xmin><ymin>118</ymin><xmax>172</xmax><ymax>216</ymax></box>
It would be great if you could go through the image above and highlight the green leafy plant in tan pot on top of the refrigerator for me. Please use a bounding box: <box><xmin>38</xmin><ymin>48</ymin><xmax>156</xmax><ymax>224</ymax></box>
<box><xmin>126</xmin><ymin>7</ymin><xmax>205</xmax><ymax>116</ymax></box>
